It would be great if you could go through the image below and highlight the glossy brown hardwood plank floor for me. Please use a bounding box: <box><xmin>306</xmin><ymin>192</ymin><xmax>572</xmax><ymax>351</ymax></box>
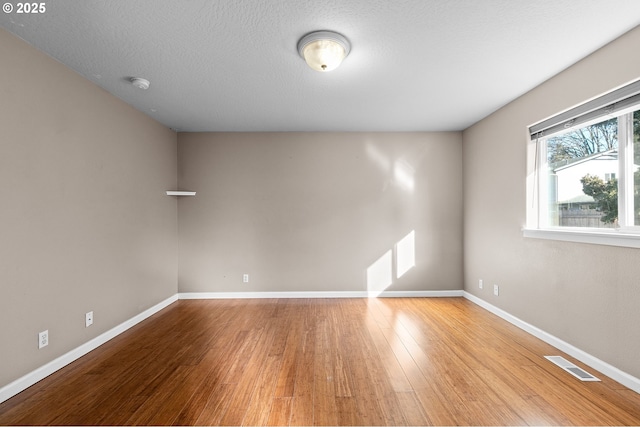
<box><xmin>0</xmin><ymin>298</ymin><xmax>640</xmax><ymax>425</ymax></box>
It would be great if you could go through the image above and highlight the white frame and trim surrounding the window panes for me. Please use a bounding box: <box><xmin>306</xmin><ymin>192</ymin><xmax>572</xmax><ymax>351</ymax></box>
<box><xmin>522</xmin><ymin>81</ymin><xmax>640</xmax><ymax>248</ymax></box>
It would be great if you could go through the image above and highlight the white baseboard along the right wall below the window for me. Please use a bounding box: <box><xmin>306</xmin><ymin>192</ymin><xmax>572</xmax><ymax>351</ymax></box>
<box><xmin>463</xmin><ymin>291</ymin><xmax>640</xmax><ymax>393</ymax></box>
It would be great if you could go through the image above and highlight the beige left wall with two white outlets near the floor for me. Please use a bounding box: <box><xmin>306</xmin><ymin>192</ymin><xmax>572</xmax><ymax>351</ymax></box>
<box><xmin>0</xmin><ymin>29</ymin><xmax>177</xmax><ymax>387</ymax></box>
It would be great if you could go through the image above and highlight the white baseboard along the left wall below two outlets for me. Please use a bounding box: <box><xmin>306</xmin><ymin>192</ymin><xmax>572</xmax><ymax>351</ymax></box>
<box><xmin>0</xmin><ymin>294</ymin><xmax>178</xmax><ymax>403</ymax></box>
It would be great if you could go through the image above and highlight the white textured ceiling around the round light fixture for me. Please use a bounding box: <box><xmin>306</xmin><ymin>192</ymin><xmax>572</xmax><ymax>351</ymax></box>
<box><xmin>0</xmin><ymin>0</ymin><xmax>640</xmax><ymax>131</ymax></box>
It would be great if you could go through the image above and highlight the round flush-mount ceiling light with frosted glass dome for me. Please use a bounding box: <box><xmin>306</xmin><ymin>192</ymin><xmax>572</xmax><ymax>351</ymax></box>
<box><xmin>298</xmin><ymin>31</ymin><xmax>351</xmax><ymax>72</ymax></box>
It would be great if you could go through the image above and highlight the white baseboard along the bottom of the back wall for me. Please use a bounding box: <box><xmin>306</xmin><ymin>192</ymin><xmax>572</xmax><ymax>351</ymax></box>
<box><xmin>178</xmin><ymin>290</ymin><xmax>463</xmax><ymax>299</ymax></box>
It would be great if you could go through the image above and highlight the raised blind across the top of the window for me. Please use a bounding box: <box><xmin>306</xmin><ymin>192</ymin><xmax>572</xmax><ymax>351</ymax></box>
<box><xmin>529</xmin><ymin>80</ymin><xmax>640</xmax><ymax>139</ymax></box>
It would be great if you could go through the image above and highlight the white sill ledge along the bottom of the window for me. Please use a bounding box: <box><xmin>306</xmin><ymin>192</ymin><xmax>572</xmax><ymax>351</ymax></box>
<box><xmin>522</xmin><ymin>228</ymin><xmax>640</xmax><ymax>248</ymax></box>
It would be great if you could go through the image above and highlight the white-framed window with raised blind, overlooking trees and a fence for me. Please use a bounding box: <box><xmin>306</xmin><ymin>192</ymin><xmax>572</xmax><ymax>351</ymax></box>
<box><xmin>525</xmin><ymin>81</ymin><xmax>640</xmax><ymax>247</ymax></box>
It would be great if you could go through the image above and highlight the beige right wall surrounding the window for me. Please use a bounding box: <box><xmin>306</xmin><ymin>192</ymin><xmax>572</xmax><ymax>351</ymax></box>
<box><xmin>463</xmin><ymin>28</ymin><xmax>640</xmax><ymax>377</ymax></box>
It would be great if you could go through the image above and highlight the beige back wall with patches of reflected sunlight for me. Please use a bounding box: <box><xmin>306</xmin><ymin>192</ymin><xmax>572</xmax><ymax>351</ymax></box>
<box><xmin>178</xmin><ymin>132</ymin><xmax>462</xmax><ymax>292</ymax></box>
